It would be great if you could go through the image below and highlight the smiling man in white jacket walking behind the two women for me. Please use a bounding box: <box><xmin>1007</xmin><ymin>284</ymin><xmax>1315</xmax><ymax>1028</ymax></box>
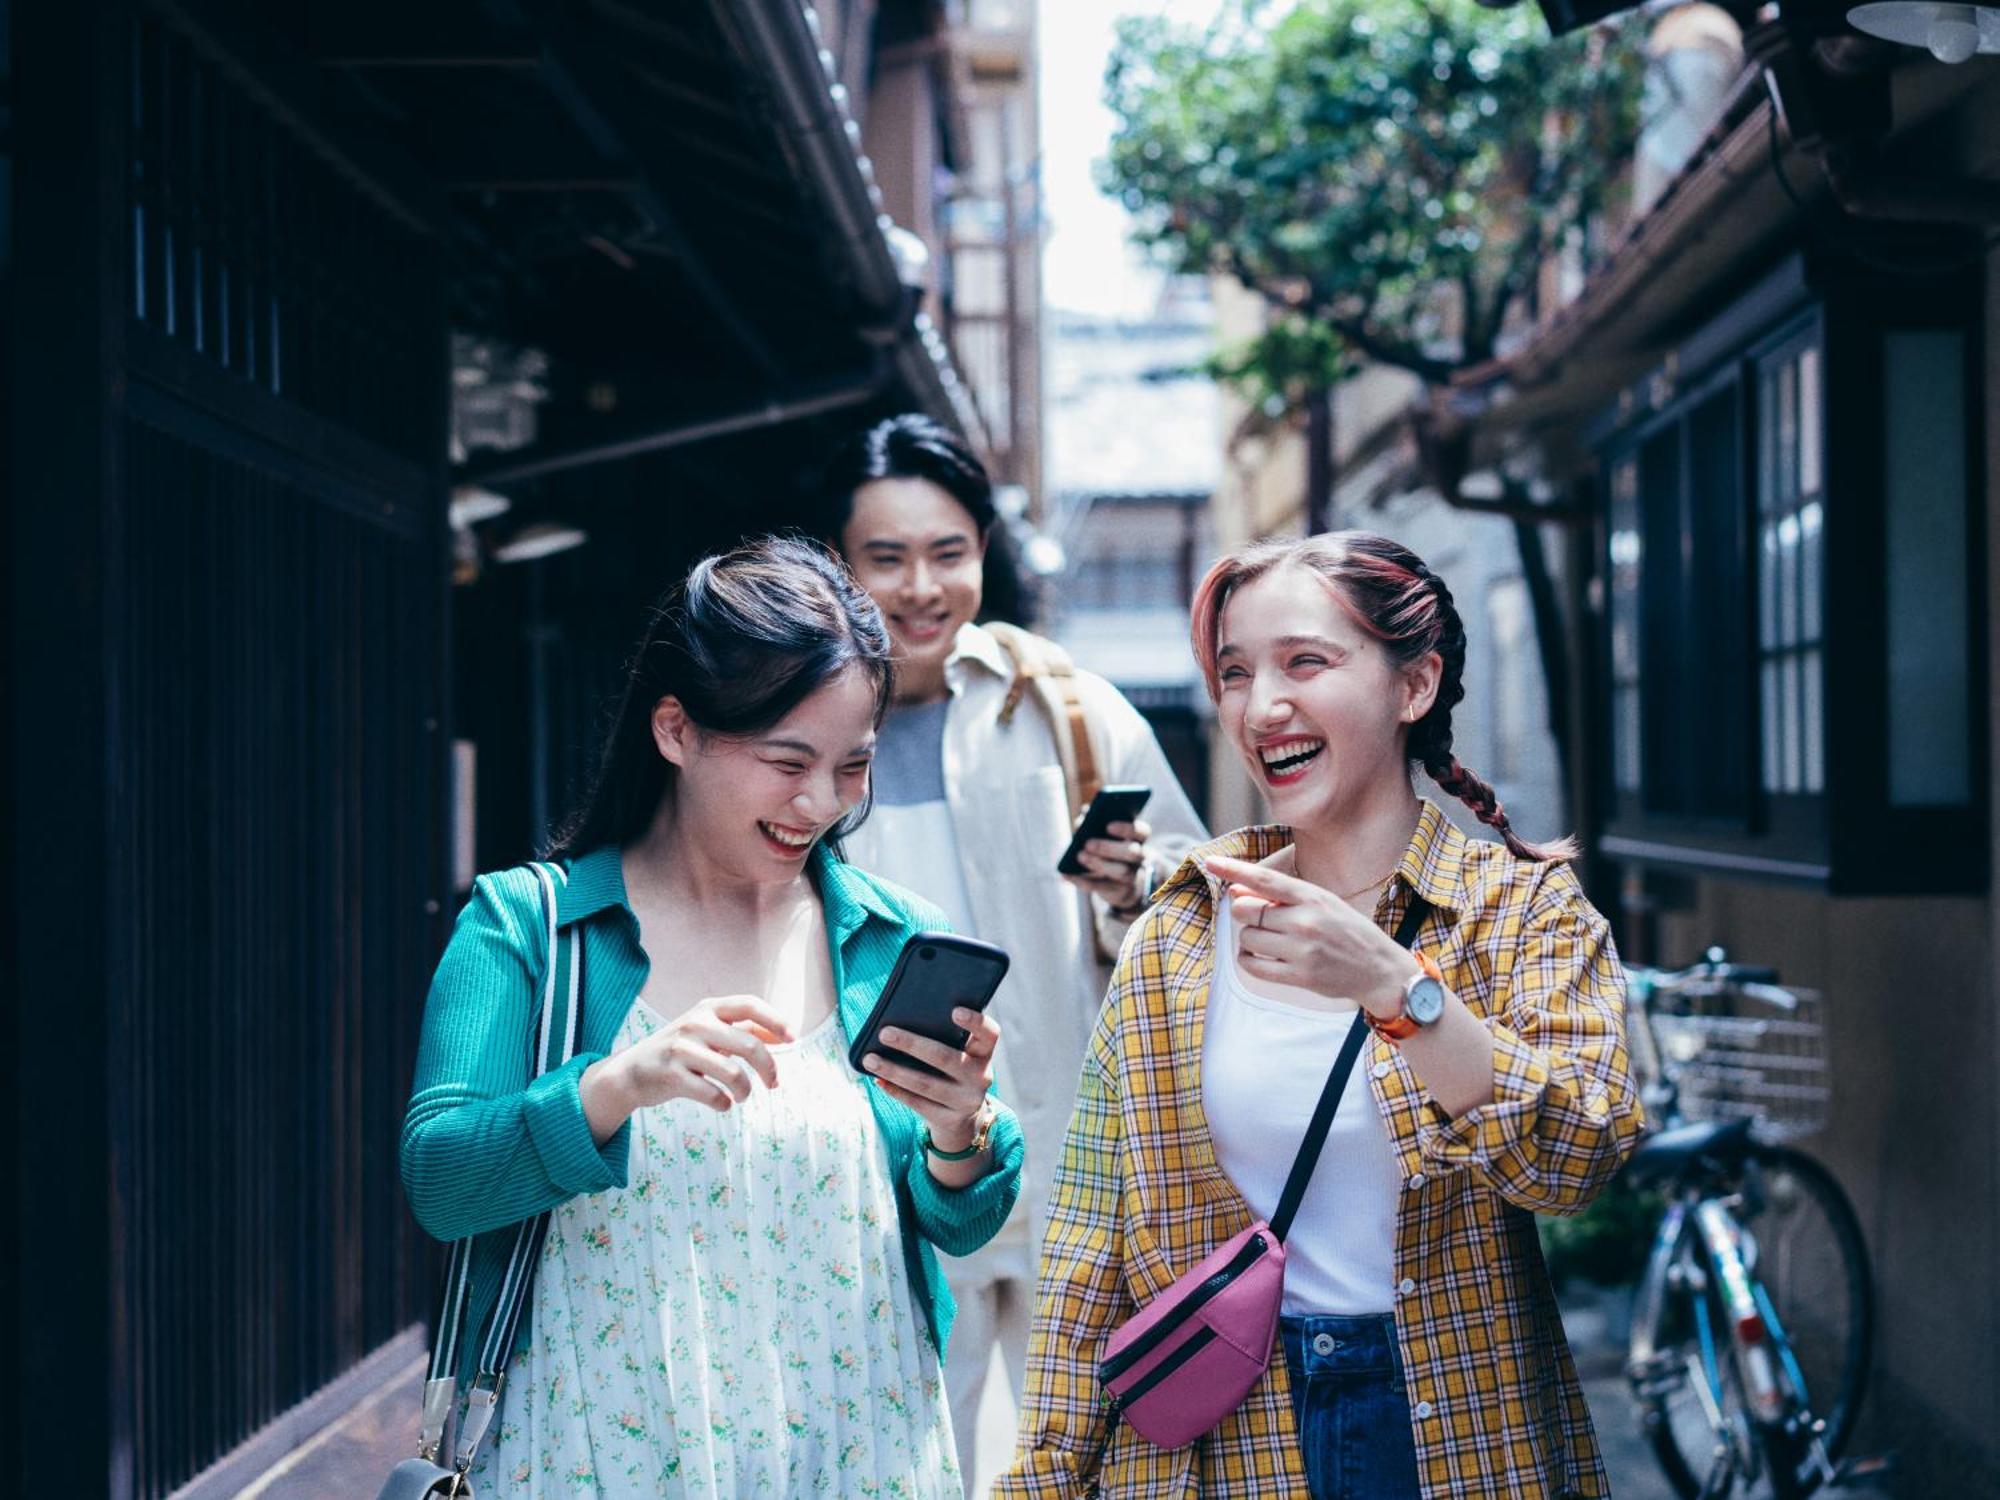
<box><xmin>826</xmin><ymin>416</ymin><xmax>1208</xmax><ymax>1486</ymax></box>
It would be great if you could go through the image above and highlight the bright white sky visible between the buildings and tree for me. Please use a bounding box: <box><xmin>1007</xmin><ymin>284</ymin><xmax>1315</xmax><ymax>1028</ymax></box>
<box><xmin>1038</xmin><ymin>0</ymin><xmax>1220</xmax><ymax>318</ymax></box>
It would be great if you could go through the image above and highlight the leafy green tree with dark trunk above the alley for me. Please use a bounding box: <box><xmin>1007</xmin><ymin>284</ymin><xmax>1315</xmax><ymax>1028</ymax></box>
<box><xmin>1102</xmin><ymin>0</ymin><xmax>1644</xmax><ymax>792</ymax></box>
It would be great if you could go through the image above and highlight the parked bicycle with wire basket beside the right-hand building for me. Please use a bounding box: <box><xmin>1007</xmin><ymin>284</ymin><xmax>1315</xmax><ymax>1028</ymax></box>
<box><xmin>1626</xmin><ymin>948</ymin><xmax>1892</xmax><ymax>1500</ymax></box>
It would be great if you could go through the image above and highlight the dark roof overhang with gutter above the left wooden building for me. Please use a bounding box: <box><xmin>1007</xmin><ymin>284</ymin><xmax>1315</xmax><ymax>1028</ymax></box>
<box><xmin>292</xmin><ymin>0</ymin><xmax>978</xmax><ymax>482</ymax></box>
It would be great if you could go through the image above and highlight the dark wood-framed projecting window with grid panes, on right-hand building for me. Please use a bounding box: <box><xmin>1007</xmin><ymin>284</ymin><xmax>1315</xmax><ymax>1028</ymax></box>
<box><xmin>1596</xmin><ymin>256</ymin><xmax>1990</xmax><ymax>894</ymax></box>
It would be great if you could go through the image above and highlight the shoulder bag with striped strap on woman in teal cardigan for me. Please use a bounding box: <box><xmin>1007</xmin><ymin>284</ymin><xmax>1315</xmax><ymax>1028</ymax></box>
<box><xmin>376</xmin><ymin>864</ymin><xmax>584</xmax><ymax>1500</ymax></box>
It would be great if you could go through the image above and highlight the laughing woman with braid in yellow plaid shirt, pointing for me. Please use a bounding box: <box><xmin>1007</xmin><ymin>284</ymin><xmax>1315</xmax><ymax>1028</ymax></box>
<box><xmin>996</xmin><ymin>532</ymin><xmax>1642</xmax><ymax>1500</ymax></box>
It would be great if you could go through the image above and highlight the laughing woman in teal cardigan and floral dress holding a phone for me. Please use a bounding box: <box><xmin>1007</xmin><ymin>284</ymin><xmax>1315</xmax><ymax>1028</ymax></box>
<box><xmin>402</xmin><ymin>542</ymin><xmax>1022</xmax><ymax>1500</ymax></box>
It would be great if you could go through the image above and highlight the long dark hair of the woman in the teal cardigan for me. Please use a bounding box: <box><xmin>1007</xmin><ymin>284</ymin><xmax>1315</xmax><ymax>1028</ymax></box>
<box><xmin>550</xmin><ymin>536</ymin><xmax>892</xmax><ymax>856</ymax></box>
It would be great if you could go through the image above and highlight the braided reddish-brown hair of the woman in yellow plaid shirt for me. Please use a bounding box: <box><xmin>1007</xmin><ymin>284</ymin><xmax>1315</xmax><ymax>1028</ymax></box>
<box><xmin>1194</xmin><ymin>532</ymin><xmax>1576</xmax><ymax>860</ymax></box>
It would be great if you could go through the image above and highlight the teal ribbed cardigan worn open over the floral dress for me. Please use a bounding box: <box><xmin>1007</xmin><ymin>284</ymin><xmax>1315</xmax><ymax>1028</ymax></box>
<box><xmin>402</xmin><ymin>846</ymin><xmax>1022</xmax><ymax>1380</ymax></box>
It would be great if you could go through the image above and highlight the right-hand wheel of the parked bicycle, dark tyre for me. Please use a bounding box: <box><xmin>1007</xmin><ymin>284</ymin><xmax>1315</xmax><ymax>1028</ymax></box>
<box><xmin>1736</xmin><ymin>1144</ymin><xmax>1874</xmax><ymax>1494</ymax></box>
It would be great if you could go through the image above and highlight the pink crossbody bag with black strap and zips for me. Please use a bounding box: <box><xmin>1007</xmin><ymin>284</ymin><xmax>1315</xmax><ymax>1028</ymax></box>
<box><xmin>1098</xmin><ymin>898</ymin><xmax>1430</xmax><ymax>1448</ymax></box>
